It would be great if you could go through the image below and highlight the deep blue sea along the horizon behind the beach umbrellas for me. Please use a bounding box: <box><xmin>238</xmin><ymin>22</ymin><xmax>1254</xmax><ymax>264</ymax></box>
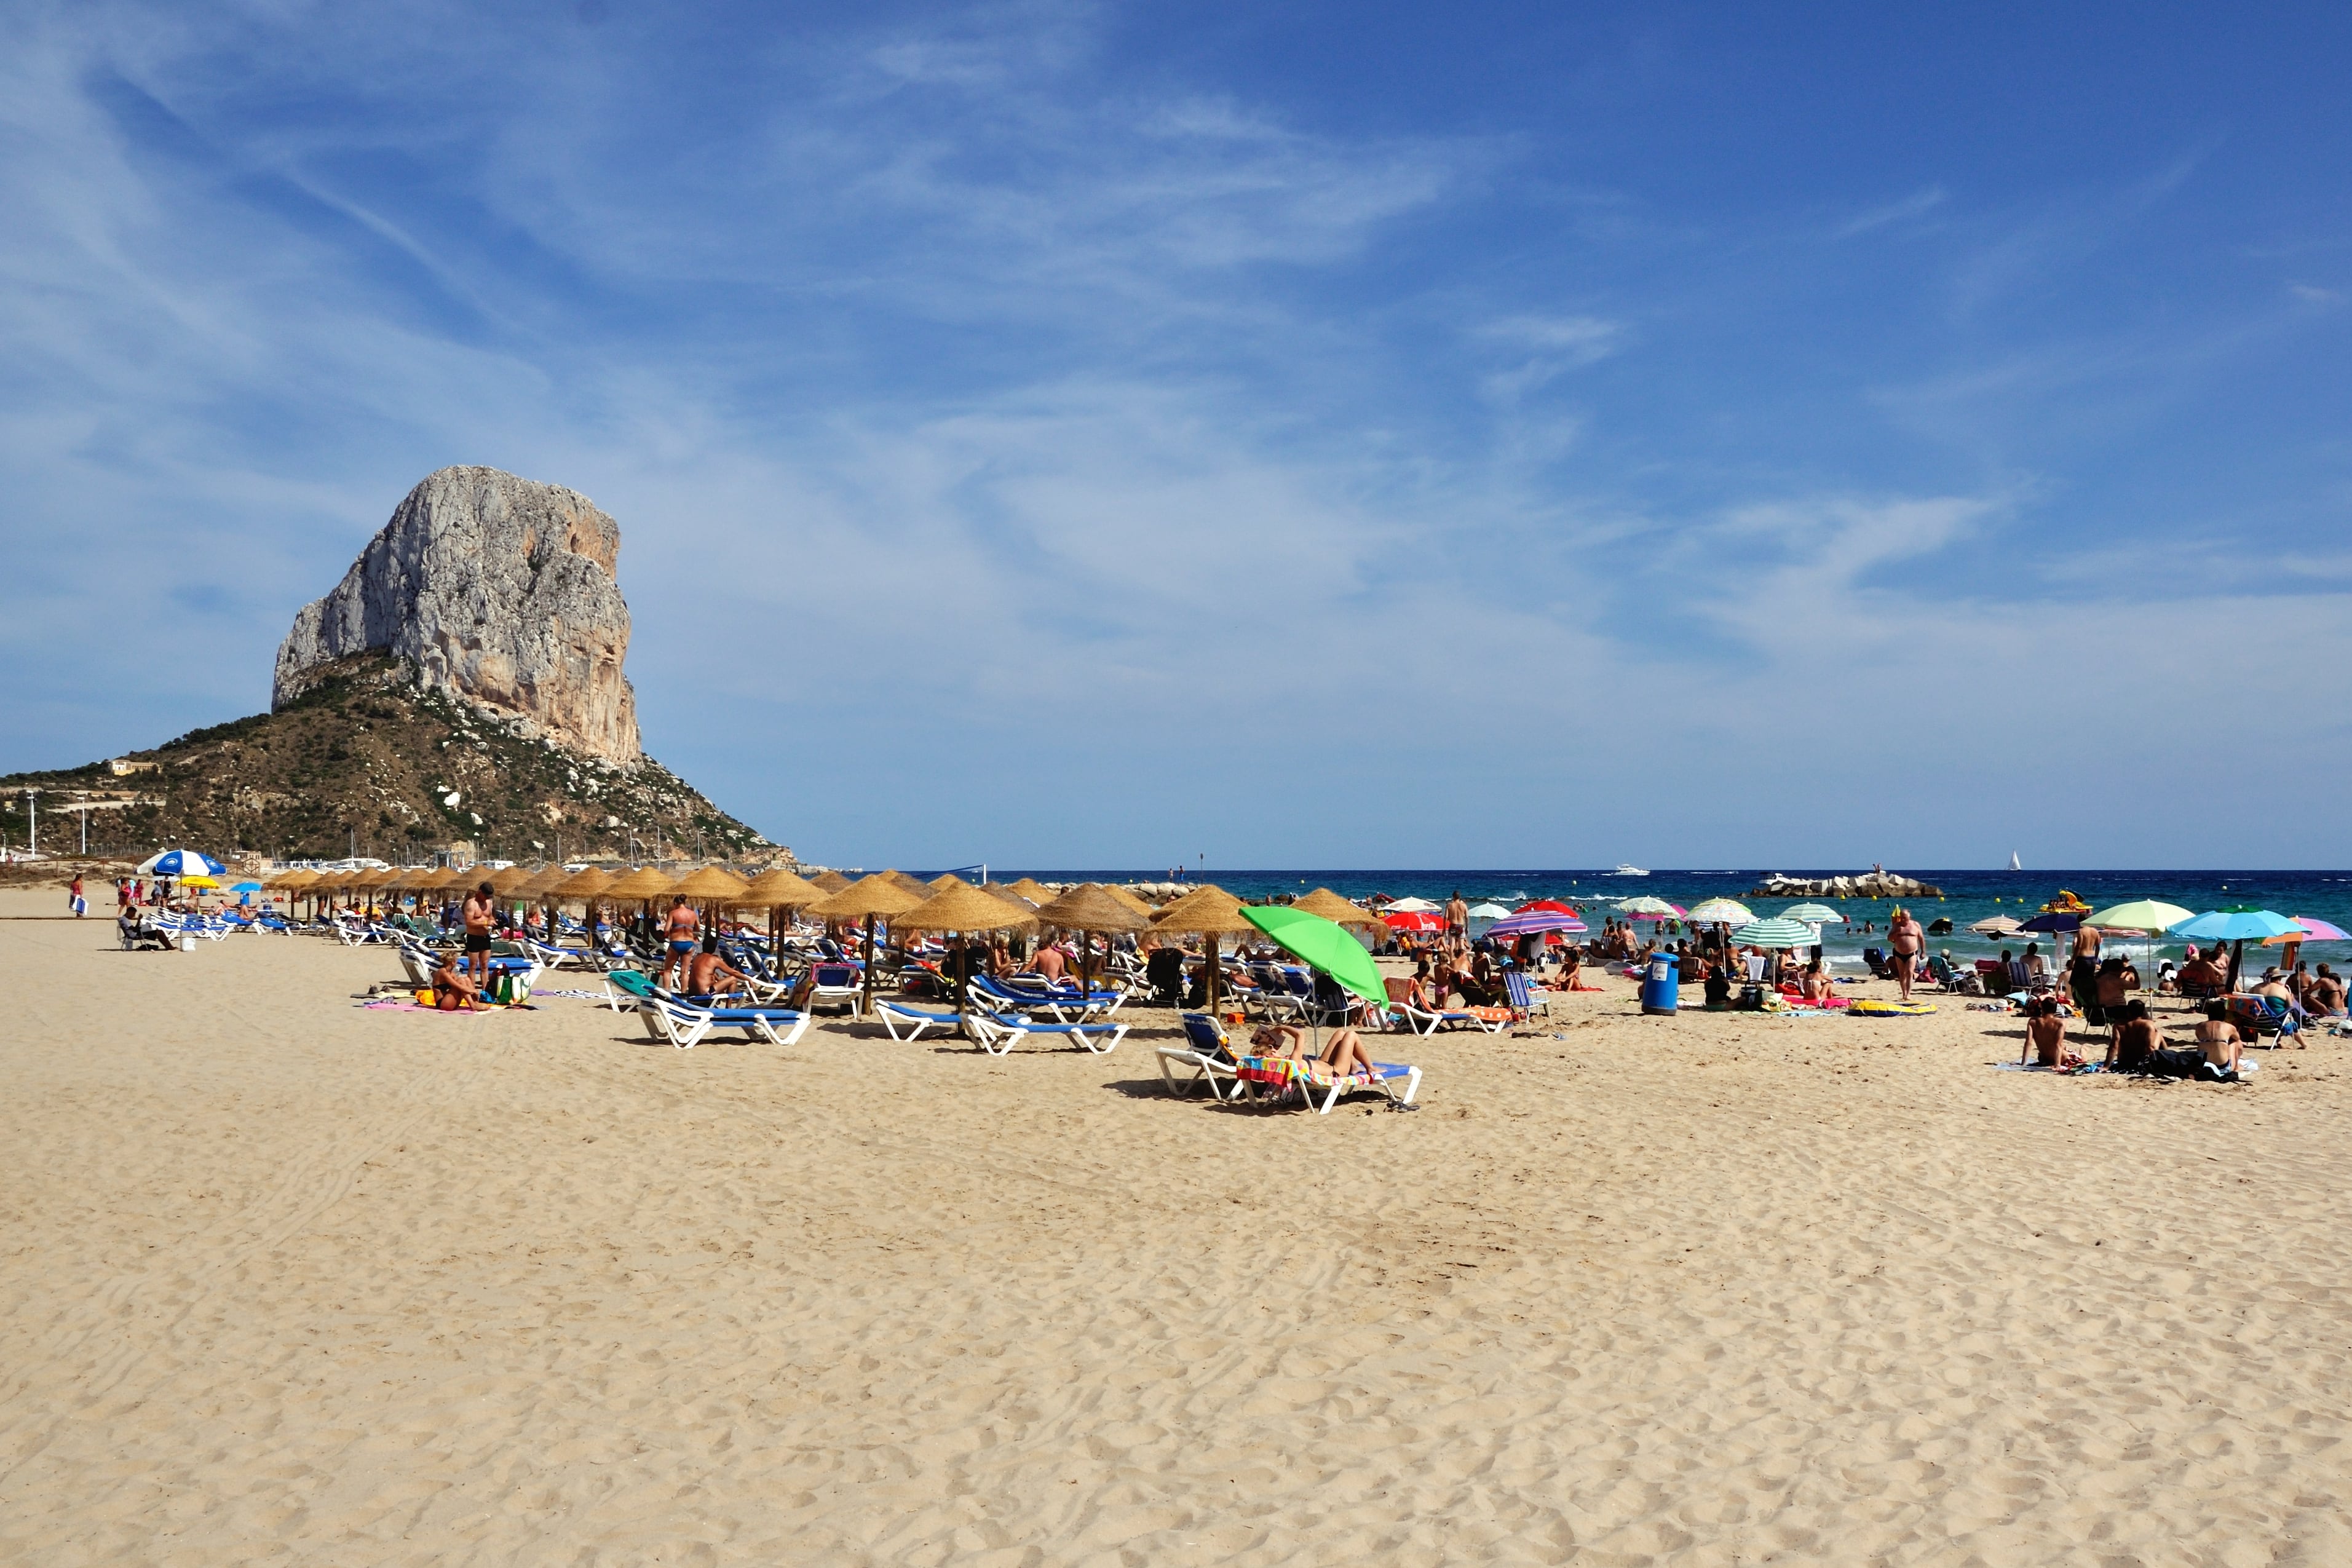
<box><xmin>990</xmin><ymin>865</ymin><xmax>2352</xmax><ymax>968</ymax></box>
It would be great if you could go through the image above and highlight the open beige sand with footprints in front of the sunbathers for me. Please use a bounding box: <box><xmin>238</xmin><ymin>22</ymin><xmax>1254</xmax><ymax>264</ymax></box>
<box><xmin>0</xmin><ymin>893</ymin><xmax>2352</xmax><ymax>1568</ymax></box>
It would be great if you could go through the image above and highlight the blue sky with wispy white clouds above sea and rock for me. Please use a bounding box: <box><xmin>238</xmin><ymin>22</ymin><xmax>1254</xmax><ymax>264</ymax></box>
<box><xmin>0</xmin><ymin>0</ymin><xmax>2352</xmax><ymax>870</ymax></box>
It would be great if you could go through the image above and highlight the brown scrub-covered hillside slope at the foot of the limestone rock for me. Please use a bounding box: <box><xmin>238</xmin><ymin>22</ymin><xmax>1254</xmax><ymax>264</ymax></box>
<box><xmin>0</xmin><ymin>654</ymin><xmax>790</xmax><ymax>865</ymax></box>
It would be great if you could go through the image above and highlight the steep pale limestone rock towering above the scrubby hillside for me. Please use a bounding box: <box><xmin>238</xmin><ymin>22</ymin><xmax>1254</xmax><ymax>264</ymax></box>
<box><xmin>271</xmin><ymin>468</ymin><xmax>644</xmax><ymax>769</ymax></box>
